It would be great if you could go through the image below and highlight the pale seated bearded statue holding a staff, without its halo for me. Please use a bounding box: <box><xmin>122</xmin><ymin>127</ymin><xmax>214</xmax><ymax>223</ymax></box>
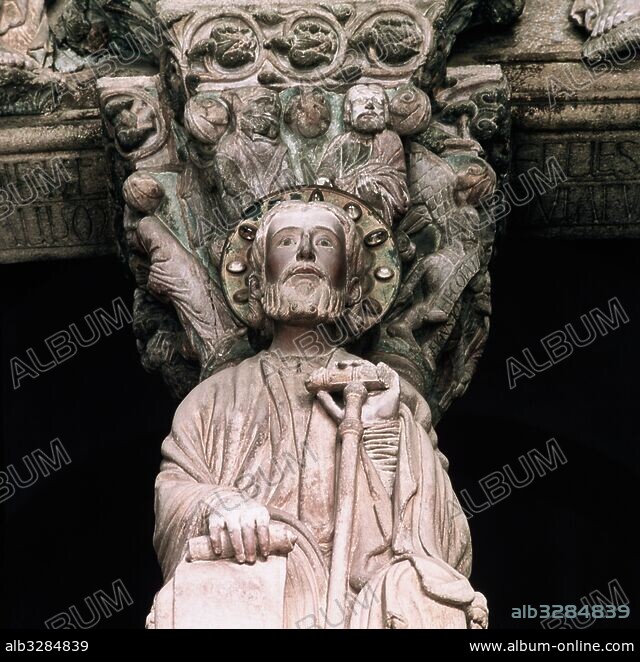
<box><xmin>150</xmin><ymin>201</ymin><xmax>487</xmax><ymax>629</ymax></box>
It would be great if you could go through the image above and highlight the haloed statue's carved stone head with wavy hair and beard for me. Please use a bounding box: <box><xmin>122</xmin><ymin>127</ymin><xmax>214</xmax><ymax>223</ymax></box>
<box><xmin>249</xmin><ymin>201</ymin><xmax>366</xmax><ymax>326</ymax></box>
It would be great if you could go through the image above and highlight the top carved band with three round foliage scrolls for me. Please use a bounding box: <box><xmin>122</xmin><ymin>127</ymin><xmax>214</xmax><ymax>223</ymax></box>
<box><xmin>157</xmin><ymin>0</ymin><xmax>435</xmax><ymax>89</ymax></box>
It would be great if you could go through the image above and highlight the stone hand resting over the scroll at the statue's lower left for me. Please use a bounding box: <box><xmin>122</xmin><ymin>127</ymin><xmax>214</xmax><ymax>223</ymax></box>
<box><xmin>208</xmin><ymin>490</ymin><xmax>270</xmax><ymax>563</ymax></box>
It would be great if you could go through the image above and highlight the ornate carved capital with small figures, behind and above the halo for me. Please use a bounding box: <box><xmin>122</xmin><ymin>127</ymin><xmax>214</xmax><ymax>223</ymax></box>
<box><xmin>98</xmin><ymin>0</ymin><xmax>509</xmax><ymax>419</ymax></box>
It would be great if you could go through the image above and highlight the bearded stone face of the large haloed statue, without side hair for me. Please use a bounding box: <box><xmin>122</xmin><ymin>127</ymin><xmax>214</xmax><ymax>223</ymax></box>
<box><xmin>263</xmin><ymin>205</ymin><xmax>347</xmax><ymax>324</ymax></box>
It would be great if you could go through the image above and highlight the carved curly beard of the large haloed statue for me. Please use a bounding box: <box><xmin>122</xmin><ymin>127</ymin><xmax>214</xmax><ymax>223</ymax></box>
<box><xmin>262</xmin><ymin>276</ymin><xmax>346</xmax><ymax>324</ymax></box>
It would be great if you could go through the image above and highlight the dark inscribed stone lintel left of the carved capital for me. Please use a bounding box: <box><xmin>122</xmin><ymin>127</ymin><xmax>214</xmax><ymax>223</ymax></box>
<box><xmin>0</xmin><ymin>111</ymin><xmax>116</xmax><ymax>262</ymax></box>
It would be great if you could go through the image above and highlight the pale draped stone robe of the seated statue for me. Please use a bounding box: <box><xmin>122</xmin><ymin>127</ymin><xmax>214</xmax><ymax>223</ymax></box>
<box><xmin>154</xmin><ymin>349</ymin><xmax>474</xmax><ymax>628</ymax></box>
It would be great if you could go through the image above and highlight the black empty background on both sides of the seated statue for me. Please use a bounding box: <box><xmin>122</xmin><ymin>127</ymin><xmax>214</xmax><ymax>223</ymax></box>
<box><xmin>0</xmin><ymin>232</ymin><xmax>640</xmax><ymax>628</ymax></box>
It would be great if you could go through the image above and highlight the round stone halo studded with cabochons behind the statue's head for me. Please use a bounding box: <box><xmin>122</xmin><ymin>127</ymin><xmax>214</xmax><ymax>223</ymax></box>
<box><xmin>220</xmin><ymin>186</ymin><xmax>401</xmax><ymax>333</ymax></box>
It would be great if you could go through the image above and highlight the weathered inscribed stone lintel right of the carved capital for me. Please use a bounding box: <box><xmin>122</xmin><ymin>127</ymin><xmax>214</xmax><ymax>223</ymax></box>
<box><xmin>453</xmin><ymin>0</ymin><xmax>640</xmax><ymax>238</ymax></box>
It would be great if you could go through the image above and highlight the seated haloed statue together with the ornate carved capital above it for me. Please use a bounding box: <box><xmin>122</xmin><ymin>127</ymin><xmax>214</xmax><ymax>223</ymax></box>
<box><xmin>92</xmin><ymin>0</ymin><xmax>521</xmax><ymax>628</ymax></box>
